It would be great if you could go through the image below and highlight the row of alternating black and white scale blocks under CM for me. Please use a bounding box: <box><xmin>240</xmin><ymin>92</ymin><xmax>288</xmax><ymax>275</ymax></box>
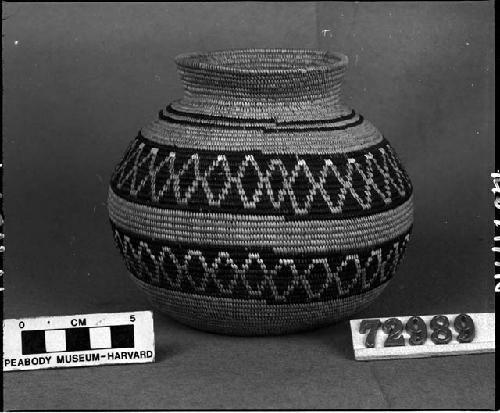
<box><xmin>21</xmin><ymin>324</ymin><xmax>134</xmax><ymax>355</ymax></box>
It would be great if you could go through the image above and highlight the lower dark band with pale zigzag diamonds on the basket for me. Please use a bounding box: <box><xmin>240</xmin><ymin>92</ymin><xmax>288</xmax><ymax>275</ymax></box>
<box><xmin>111</xmin><ymin>223</ymin><xmax>411</xmax><ymax>304</ymax></box>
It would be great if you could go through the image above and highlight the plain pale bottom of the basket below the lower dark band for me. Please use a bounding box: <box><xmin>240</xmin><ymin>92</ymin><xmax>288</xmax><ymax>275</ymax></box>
<box><xmin>129</xmin><ymin>274</ymin><xmax>387</xmax><ymax>336</ymax></box>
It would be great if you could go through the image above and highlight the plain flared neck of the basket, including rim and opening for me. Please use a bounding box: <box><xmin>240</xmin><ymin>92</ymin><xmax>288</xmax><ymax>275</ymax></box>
<box><xmin>176</xmin><ymin>50</ymin><xmax>347</xmax><ymax>105</ymax></box>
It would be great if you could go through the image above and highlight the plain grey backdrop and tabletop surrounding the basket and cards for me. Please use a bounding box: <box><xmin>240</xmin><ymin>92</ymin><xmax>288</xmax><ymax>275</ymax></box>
<box><xmin>2</xmin><ymin>1</ymin><xmax>494</xmax><ymax>409</ymax></box>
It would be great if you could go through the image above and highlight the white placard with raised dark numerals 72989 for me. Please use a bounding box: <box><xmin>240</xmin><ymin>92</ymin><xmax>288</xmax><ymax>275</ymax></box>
<box><xmin>351</xmin><ymin>313</ymin><xmax>495</xmax><ymax>360</ymax></box>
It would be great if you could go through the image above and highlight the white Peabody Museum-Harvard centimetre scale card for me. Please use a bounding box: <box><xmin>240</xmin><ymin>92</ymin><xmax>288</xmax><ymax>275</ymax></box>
<box><xmin>3</xmin><ymin>311</ymin><xmax>155</xmax><ymax>371</ymax></box>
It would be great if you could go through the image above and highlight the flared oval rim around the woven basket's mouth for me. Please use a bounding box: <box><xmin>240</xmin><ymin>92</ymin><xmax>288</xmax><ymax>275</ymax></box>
<box><xmin>174</xmin><ymin>48</ymin><xmax>349</xmax><ymax>75</ymax></box>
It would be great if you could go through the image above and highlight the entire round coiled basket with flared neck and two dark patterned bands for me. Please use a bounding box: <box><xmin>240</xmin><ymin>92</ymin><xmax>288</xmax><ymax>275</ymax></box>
<box><xmin>108</xmin><ymin>50</ymin><xmax>413</xmax><ymax>335</ymax></box>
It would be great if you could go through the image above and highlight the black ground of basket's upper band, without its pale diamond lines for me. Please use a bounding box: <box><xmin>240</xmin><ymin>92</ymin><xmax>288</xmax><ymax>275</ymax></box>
<box><xmin>111</xmin><ymin>136</ymin><xmax>412</xmax><ymax>220</ymax></box>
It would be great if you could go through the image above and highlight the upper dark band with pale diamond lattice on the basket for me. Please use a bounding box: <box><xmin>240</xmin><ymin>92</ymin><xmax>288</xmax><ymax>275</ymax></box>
<box><xmin>111</xmin><ymin>137</ymin><xmax>412</xmax><ymax>219</ymax></box>
